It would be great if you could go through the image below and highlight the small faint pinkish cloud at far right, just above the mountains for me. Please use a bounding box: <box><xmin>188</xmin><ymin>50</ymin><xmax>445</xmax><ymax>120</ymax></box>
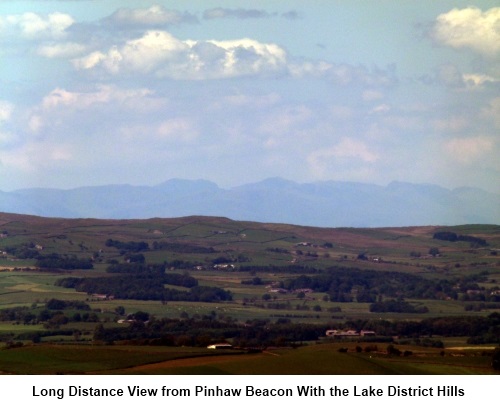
<box><xmin>444</xmin><ymin>136</ymin><xmax>495</xmax><ymax>164</ymax></box>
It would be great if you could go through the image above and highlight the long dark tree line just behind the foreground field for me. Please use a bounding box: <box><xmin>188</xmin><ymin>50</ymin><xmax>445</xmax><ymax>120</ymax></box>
<box><xmin>94</xmin><ymin>313</ymin><xmax>500</xmax><ymax>347</ymax></box>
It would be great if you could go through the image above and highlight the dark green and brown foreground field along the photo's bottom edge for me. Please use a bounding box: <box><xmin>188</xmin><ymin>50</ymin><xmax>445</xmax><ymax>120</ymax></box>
<box><xmin>0</xmin><ymin>343</ymin><xmax>494</xmax><ymax>375</ymax></box>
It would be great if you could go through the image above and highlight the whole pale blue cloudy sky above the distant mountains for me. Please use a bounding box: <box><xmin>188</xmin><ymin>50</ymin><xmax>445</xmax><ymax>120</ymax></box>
<box><xmin>0</xmin><ymin>0</ymin><xmax>500</xmax><ymax>193</ymax></box>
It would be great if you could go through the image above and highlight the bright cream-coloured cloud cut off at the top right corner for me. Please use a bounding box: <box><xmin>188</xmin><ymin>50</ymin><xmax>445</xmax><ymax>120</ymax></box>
<box><xmin>431</xmin><ymin>7</ymin><xmax>500</xmax><ymax>56</ymax></box>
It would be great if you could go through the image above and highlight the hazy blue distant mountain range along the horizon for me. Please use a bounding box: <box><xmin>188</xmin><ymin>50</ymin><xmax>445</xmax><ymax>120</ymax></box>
<box><xmin>0</xmin><ymin>178</ymin><xmax>500</xmax><ymax>227</ymax></box>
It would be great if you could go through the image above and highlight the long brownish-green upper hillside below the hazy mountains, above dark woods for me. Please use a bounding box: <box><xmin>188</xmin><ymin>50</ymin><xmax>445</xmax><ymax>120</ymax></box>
<box><xmin>0</xmin><ymin>208</ymin><xmax>500</xmax><ymax>274</ymax></box>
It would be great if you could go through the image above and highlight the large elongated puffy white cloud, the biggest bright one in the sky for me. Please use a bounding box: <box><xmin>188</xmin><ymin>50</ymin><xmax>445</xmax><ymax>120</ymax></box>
<box><xmin>73</xmin><ymin>30</ymin><xmax>286</xmax><ymax>80</ymax></box>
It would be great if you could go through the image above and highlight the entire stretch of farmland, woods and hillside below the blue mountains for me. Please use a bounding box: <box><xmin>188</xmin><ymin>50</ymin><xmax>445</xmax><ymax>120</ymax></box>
<box><xmin>0</xmin><ymin>213</ymin><xmax>500</xmax><ymax>374</ymax></box>
